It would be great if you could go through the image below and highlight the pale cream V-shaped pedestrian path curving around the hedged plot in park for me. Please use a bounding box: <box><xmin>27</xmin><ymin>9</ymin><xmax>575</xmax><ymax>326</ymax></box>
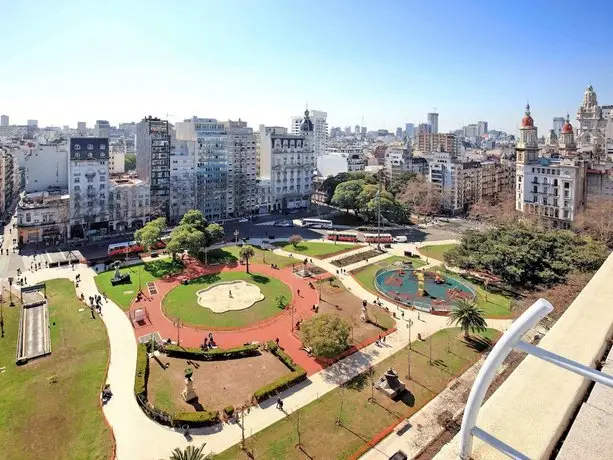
<box><xmin>22</xmin><ymin>239</ymin><xmax>510</xmax><ymax>460</ymax></box>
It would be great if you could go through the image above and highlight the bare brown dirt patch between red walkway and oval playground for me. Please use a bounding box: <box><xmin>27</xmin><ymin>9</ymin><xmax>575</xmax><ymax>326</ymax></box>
<box><xmin>317</xmin><ymin>280</ymin><xmax>394</xmax><ymax>344</ymax></box>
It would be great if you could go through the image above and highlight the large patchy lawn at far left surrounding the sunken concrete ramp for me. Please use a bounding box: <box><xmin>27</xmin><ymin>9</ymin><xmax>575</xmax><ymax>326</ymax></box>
<box><xmin>0</xmin><ymin>280</ymin><xmax>113</xmax><ymax>460</ymax></box>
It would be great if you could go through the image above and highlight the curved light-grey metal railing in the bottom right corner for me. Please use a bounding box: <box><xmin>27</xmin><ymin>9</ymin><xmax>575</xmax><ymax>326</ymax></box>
<box><xmin>458</xmin><ymin>299</ymin><xmax>613</xmax><ymax>460</ymax></box>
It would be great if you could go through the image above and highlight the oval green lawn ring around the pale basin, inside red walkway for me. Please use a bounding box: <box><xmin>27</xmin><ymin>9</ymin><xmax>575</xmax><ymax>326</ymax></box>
<box><xmin>162</xmin><ymin>272</ymin><xmax>292</xmax><ymax>328</ymax></box>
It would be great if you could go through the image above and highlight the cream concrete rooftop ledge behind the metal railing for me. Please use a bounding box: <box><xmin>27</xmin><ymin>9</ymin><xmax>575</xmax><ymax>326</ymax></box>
<box><xmin>435</xmin><ymin>255</ymin><xmax>613</xmax><ymax>460</ymax></box>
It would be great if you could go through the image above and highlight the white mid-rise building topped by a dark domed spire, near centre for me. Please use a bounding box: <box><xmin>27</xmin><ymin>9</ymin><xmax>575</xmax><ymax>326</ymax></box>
<box><xmin>260</xmin><ymin>110</ymin><xmax>316</xmax><ymax>210</ymax></box>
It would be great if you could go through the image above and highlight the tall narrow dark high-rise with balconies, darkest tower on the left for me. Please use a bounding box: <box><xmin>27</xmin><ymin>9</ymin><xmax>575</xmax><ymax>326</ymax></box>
<box><xmin>136</xmin><ymin>116</ymin><xmax>174</xmax><ymax>219</ymax></box>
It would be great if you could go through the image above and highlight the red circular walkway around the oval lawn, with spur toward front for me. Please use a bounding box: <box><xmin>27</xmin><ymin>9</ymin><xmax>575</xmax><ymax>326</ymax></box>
<box><xmin>131</xmin><ymin>259</ymin><xmax>329</xmax><ymax>375</ymax></box>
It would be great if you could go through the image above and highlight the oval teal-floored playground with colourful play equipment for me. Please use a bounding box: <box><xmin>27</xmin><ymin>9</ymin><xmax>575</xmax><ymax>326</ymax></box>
<box><xmin>375</xmin><ymin>267</ymin><xmax>476</xmax><ymax>312</ymax></box>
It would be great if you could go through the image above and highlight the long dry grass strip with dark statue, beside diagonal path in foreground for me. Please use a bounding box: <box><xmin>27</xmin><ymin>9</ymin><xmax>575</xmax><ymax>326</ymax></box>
<box><xmin>213</xmin><ymin>328</ymin><xmax>500</xmax><ymax>460</ymax></box>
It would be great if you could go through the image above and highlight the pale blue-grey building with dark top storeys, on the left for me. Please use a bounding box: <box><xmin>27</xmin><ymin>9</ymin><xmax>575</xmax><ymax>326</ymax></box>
<box><xmin>68</xmin><ymin>137</ymin><xmax>109</xmax><ymax>238</ymax></box>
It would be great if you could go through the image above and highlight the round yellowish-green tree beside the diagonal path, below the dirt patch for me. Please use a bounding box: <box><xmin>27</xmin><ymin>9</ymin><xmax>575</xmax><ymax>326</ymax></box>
<box><xmin>300</xmin><ymin>313</ymin><xmax>350</xmax><ymax>358</ymax></box>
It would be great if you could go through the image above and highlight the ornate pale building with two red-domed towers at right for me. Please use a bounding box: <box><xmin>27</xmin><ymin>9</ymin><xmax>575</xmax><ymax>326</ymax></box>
<box><xmin>515</xmin><ymin>105</ymin><xmax>587</xmax><ymax>228</ymax></box>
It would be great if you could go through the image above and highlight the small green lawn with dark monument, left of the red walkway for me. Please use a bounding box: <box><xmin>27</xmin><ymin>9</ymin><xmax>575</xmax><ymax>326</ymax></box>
<box><xmin>95</xmin><ymin>258</ymin><xmax>183</xmax><ymax>311</ymax></box>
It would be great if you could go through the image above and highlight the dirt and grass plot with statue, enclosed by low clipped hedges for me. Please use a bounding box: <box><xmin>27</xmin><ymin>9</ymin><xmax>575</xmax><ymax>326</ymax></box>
<box><xmin>147</xmin><ymin>352</ymin><xmax>290</xmax><ymax>413</ymax></box>
